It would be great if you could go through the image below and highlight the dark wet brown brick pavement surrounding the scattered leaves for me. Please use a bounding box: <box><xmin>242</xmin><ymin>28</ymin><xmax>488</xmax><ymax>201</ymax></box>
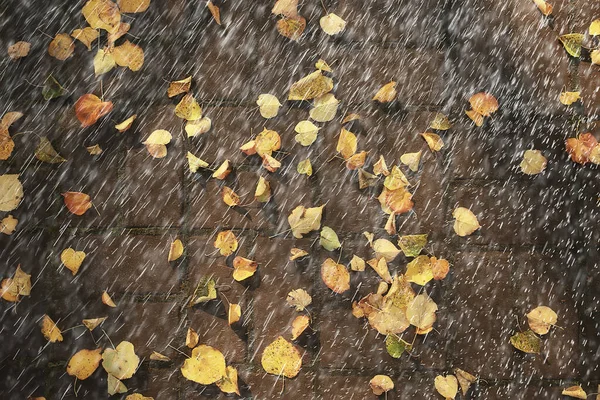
<box><xmin>0</xmin><ymin>0</ymin><xmax>600</xmax><ymax>400</ymax></box>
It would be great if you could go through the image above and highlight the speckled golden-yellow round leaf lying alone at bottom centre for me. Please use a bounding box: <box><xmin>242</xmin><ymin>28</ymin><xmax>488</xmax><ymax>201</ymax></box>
<box><xmin>260</xmin><ymin>336</ymin><xmax>302</xmax><ymax>378</ymax></box>
